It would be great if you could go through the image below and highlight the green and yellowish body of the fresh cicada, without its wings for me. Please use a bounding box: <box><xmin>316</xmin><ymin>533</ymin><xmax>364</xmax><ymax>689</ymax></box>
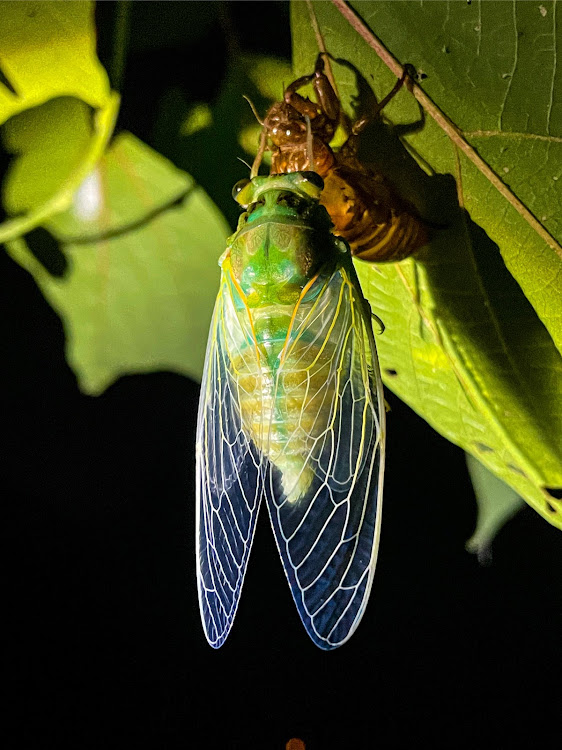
<box><xmin>223</xmin><ymin>174</ymin><xmax>341</xmax><ymax>501</ymax></box>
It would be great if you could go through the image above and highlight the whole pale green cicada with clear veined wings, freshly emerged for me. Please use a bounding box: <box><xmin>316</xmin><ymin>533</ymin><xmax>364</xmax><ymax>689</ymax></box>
<box><xmin>197</xmin><ymin>171</ymin><xmax>385</xmax><ymax>650</ymax></box>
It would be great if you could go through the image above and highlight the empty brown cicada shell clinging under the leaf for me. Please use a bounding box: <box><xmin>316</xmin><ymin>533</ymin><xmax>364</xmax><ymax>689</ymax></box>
<box><xmin>253</xmin><ymin>55</ymin><xmax>429</xmax><ymax>263</ymax></box>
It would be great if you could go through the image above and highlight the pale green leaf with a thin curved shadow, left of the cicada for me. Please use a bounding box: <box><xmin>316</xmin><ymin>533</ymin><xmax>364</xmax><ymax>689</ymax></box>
<box><xmin>4</xmin><ymin>133</ymin><xmax>228</xmax><ymax>395</ymax></box>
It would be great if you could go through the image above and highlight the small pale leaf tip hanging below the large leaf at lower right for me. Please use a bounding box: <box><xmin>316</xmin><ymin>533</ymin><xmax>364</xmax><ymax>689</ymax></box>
<box><xmin>466</xmin><ymin>453</ymin><xmax>525</xmax><ymax>563</ymax></box>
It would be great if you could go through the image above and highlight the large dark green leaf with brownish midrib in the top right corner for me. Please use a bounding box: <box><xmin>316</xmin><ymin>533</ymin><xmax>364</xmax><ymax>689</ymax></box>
<box><xmin>318</xmin><ymin>0</ymin><xmax>562</xmax><ymax>350</ymax></box>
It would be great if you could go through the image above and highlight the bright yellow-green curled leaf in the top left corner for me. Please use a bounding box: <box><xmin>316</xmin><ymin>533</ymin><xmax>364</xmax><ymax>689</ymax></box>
<box><xmin>0</xmin><ymin>0</ymin><xmax>119</xmax><ymax>242</ymax></box>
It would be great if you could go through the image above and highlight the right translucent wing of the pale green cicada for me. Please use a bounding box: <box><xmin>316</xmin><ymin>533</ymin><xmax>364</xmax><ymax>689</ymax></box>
<box><xmin>266</xmin><ymin>267</ymin><xmax>385</xmax><ymax>649</ymax></box>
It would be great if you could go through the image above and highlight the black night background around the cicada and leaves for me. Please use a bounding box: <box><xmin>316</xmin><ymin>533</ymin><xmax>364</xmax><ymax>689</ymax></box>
<box><xmin>0</xmin><ymin>2</ymin><xmax>562</xmax><ymax>750</ymax></box>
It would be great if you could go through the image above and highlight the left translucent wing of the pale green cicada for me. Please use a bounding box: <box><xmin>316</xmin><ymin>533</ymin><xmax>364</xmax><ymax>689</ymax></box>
<box><xmin>196</xmin><ymin>272</ymin><xmax>263</xmax><ymax>648</ymax></box>
